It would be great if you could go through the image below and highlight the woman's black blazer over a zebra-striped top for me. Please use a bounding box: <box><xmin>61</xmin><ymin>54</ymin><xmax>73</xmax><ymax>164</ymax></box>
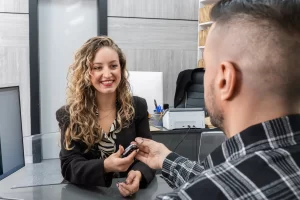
<box><xmin>56</xmin><ymin>97</ymin><xmax>155</xmax><ymax>188</ymax></box>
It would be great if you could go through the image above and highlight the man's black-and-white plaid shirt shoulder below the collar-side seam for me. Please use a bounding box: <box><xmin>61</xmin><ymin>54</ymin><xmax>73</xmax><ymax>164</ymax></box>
<box><xmin>188</xmin><ymin>149</ymin><xmax>300</xmax><ymax>199</ymax></box>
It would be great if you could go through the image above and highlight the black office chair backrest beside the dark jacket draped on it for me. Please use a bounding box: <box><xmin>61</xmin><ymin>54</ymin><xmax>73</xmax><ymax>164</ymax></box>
<box><xmin>177</xmin><ymin>68</ymin><xmax>205</xmax><ymax>108</ymax></box>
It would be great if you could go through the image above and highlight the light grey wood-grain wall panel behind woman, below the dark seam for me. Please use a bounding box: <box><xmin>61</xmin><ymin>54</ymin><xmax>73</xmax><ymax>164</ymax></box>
<box><xmin>108</xmin><ymin>17</ymin><xmax>198</xmax><ymax>105</ymax></box>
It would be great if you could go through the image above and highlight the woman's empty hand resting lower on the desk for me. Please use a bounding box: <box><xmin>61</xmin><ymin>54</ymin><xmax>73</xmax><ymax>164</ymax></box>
<box><xmin>117</xmin><ymin>170</ymin><xmax>142</xmax><ymax>197</ymax></box>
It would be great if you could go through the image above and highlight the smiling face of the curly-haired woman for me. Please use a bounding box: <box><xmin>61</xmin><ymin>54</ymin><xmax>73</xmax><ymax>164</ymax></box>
<box><xmin>91</xmin><ymin>47</ymin><xmax>121</xmax><ymax>94</ymax></box>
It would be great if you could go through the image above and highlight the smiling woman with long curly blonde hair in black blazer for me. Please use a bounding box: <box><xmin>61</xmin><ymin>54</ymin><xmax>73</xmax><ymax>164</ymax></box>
<box><xmin>56</xmin><ymin>36</ymin><xmax>155</xmax><ymax>196</ymax></box>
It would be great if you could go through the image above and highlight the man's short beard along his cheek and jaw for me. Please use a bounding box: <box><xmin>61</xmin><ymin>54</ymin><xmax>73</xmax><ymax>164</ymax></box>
<box><xmin>205</xmin><ymin>84</ymin><xmax>224</xmax><ymax>131</ymax></box>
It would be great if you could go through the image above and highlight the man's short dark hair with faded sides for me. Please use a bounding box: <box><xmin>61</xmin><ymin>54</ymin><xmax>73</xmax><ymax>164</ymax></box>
<box><xmin>210</xmin><ymin>0</ymin><xmax>300</xmax><ymax>99</ymax></box>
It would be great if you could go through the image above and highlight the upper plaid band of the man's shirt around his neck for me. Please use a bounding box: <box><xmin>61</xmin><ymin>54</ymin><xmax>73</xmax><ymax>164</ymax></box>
<box><xmin>205</xmin><ymin>114</ymin><xmax>300</xmax><ymax>167</ymax></box>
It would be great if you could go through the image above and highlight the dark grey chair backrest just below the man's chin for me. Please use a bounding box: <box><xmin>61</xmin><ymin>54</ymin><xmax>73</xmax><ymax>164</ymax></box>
<box><xmin>198</xmin><ymin>131</ymin><xmax>226</xmax><ymax>163</ymax></box>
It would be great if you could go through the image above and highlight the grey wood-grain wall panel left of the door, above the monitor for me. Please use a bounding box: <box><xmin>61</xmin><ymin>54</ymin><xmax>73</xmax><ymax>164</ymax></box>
<box><xmin>0</xmin><ymin>13</ymin><xmax>31</xmax><ymax>136</ymax></box>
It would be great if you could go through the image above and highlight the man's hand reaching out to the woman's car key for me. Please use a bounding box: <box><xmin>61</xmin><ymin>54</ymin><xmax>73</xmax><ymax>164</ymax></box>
<box><xmin>135</xmin><ymin>138</ymin><xmax>171</xmax><ymax>169</ymax></box>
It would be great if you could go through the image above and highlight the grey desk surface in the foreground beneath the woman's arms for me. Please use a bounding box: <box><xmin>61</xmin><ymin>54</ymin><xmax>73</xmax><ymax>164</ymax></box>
<box><xmin>0</xmin><ymin>176</ymin><xmax>172</xmax><ymax>200</ymax></box>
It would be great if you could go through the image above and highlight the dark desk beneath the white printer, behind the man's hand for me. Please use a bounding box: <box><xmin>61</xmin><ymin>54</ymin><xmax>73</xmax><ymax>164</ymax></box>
<box><xmin>151</xmin><ymin>128</ymin><xmax>219</xmax><ymax>161</ymax></box>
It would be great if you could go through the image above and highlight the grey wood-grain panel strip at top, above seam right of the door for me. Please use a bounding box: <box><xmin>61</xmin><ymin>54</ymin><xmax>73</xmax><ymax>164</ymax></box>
<box><xmin>108</xmin><ymin>0</ymin><xmax>199</xmax><ymax>20</ymax></box>
